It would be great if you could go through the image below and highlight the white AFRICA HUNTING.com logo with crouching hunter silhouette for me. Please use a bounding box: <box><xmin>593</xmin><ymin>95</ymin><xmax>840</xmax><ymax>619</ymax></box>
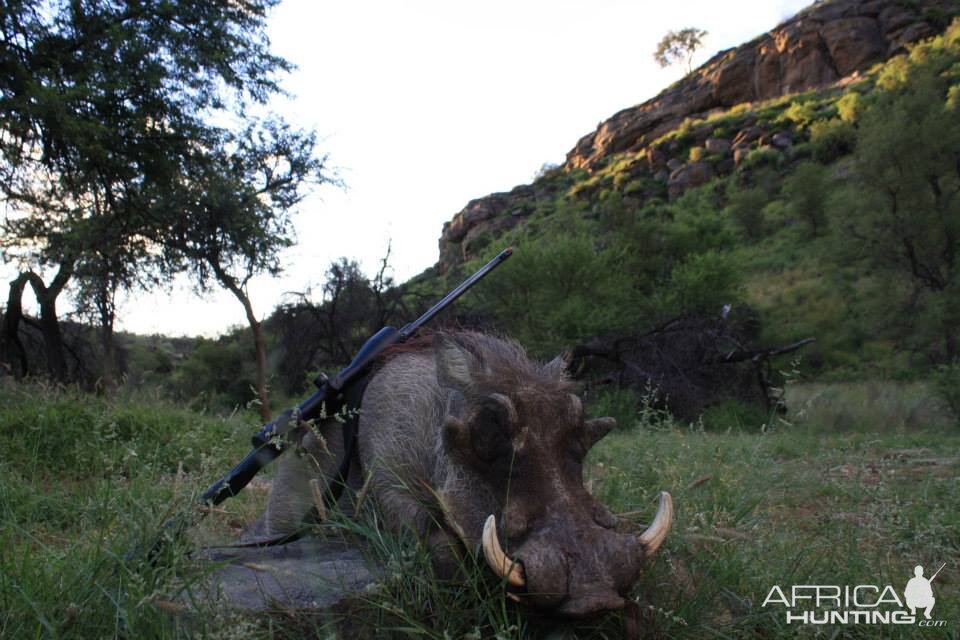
<box><xmin>762</xmin><ymin>563</ymin><xmax>947</xmax><ymax>627</ymax></box>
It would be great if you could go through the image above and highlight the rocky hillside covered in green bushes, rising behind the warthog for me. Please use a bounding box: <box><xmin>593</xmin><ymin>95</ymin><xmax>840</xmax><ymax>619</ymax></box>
<box><xmin>434</xmin><ymin>0</ymin><xmax>960</xmax><ymax>390</ymax></box>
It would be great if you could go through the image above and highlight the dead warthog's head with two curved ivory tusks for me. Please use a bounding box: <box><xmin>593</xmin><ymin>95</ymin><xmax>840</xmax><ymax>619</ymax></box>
<box><xmin>434</xmin><ymin>334</ymin><xmax>673</xmax><ymax>617</ymax></box>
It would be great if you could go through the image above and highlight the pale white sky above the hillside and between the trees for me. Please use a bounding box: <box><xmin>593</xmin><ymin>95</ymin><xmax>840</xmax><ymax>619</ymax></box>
<box><xmin>0</xmin><ymin>0</ymin><xmax>811</xmax><ymax>336</ymax></box>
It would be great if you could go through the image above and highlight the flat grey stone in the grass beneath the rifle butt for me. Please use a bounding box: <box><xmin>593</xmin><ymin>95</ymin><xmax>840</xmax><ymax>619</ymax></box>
<box><xmin>180</xmin><ymin>538</ymin><xmax>378</xmax><ymax>613</ymax></box>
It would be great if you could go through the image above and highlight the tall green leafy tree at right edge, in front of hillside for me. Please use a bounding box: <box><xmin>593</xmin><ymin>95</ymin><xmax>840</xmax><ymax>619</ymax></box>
<box><xmin>848</xmin><ymin>24</ymin><xmax>960</xmax><ymax>362</ymax></box>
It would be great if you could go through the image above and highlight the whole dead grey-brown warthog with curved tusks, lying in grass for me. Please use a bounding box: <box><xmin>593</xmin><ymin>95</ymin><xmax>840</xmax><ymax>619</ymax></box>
<box><xmin>246</xmin><ymin>333</ymin><xmax>673</xmax><ymax>617</ymax></box>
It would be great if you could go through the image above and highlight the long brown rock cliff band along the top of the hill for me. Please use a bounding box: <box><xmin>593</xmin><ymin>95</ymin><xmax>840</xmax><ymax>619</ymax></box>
<box><xmin>567</xmin><ymin>0</ymin><xmax>956</xmax><ymax>169</ymax></box>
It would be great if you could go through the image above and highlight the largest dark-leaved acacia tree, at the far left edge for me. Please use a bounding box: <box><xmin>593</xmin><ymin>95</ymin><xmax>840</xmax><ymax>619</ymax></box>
<box><xmin>0</xmin><ymin>0</ymin><xmax>302</xmax><ymax>379</ymax></box>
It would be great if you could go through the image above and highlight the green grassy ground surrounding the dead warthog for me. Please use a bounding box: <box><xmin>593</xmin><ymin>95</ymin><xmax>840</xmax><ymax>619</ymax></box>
<box><xmin>0</xmin><ymin>384</ymin><xmax>960</xmax><ymax>639</ymax></box>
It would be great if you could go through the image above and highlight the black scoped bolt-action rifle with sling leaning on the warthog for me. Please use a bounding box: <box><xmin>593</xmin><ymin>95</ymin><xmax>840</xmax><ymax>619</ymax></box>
<box><xmin>134</xmin><ymin>247</ymin><xmax>513</xmax><ymax>564</ymax></box>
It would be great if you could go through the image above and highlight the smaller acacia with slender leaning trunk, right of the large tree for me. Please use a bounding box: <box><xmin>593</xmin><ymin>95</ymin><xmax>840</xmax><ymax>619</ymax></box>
<box><xmin>164</xmin><ymin>120</ymin><xmax>331</xmax><ymax>421</ymax></box>
